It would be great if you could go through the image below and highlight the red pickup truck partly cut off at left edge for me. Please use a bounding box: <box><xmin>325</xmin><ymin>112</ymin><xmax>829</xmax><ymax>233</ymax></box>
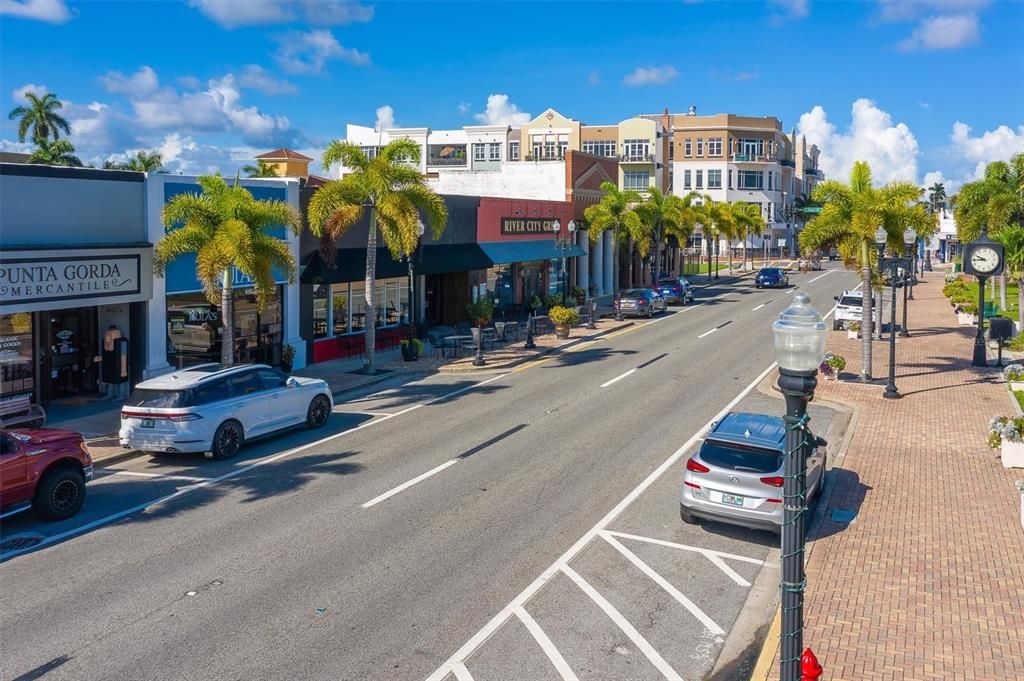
<box><xmin>0</xmin><ymin>428</ymin><xmax>92</xmax><ymax>520</ymax></box>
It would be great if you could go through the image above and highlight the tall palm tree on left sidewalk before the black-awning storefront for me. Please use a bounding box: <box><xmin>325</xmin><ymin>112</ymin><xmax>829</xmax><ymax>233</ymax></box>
<box><xmin>308</xmin><ymin>139</ymin><xmax>447</xmax><ymax>374</ymax></box>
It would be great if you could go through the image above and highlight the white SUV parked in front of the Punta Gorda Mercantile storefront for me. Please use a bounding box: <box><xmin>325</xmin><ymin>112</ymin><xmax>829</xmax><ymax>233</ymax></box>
<box><xmin>119</xmin><ymin>364</ymin><xmax>334</xmax><ymax>459</ymax></box>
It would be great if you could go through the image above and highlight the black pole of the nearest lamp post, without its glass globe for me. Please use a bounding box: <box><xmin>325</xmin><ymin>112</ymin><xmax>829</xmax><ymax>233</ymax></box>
<box><xmin>778</xmin><ymin>369</ymin><xmax>818</xmax><ymax>681</ymax></box>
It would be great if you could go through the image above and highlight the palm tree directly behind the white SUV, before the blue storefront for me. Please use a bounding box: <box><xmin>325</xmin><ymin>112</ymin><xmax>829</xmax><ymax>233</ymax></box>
<box><xmin>154</xmin><ymin>176</ymin><xmax>302</xmax><ymax>366</ymax></box>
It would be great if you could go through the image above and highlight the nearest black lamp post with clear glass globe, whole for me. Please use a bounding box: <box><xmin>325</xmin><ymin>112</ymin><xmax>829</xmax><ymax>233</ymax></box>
<box><xmin>772</xmin><ymin>291</ymin><xmax>827</xmax><ymax>681</ymax></box>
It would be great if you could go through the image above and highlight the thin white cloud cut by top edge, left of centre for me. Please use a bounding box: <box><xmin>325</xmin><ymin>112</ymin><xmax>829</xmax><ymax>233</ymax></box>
<box><xmin>188</xmin><ymin>0</ymin><xmax>374</xmax><ymax>29</ymax></box>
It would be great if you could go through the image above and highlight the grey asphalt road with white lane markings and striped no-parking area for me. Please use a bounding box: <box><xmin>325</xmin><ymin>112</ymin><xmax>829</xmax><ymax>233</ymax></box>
<box><xmin>0</xmin><ymin>270</ymin><xmax>855</xmax><ymax>681</ymax></box>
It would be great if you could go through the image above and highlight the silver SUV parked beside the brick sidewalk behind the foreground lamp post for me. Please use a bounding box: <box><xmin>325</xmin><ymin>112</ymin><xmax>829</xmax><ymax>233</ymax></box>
<box><xmin>679</xmin><ymin>412</ymin><xmax>827</xmax><ymax>531</ymax></box>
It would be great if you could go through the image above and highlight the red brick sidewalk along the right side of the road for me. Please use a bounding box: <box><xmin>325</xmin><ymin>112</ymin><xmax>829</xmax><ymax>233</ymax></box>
<box><xmin>769</xmin><ymin>272</ymin><xmax>1024</xmax><ymax>681</ymax></box>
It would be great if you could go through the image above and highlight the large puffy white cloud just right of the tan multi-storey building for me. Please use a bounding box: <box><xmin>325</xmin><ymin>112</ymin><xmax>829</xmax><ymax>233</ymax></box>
<box><xmin>797</xmin><ymin>98</ymin><xmax>919</xmax><ymax>183</ymax></box>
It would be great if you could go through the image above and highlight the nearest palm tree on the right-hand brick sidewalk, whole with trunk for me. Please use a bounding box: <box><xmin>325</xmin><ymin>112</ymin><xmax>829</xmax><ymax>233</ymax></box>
<box><xmin>800</xmin><ymin>161</ymin><xmax>922</xmax><ymax>381</ymax></box>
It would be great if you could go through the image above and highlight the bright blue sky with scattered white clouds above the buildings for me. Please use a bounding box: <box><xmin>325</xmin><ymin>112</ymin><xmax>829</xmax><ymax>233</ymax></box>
<box><xmin>0</xmin><ymin>0</ymin><xmax>1024</xmax><ymax>188</ymax></box>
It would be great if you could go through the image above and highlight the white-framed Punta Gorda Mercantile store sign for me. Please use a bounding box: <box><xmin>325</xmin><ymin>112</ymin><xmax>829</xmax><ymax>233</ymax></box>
<box><xmin>0</xmin><ymin>255</ymin><xmax>141</xmax><ymax>307</ymax></box>
